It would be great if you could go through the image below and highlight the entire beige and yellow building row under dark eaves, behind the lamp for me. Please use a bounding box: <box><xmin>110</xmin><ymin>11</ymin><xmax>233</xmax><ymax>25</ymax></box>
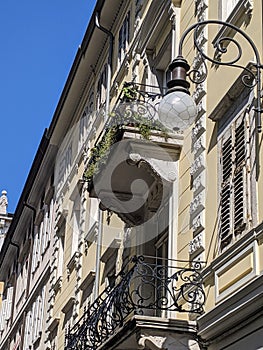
<box><xmin>0</xmin><ymin>0</ymin><xmax>263</xmax><ymax>350</ymax></box>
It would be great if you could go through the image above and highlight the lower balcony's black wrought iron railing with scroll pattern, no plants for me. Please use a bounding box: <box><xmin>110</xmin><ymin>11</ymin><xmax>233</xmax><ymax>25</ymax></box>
<box><xmin>65</xmin><ymin>256</ymin><xmax>205</xmax><ymax>350</ymax></box>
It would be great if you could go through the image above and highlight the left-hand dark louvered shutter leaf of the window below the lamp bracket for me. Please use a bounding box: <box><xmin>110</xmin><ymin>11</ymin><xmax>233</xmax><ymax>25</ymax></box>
<box><xmin>220</xmin><ymin>134</ymin><xmax>232</xmax><ymax>248</ymax></box>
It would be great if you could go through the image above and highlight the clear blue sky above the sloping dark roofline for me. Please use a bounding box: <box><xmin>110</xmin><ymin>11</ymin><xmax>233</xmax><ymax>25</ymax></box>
<box><xmin>0</xmin><ymin>0</ymin><xmax>96</xmax><ymax>212</ymax></box>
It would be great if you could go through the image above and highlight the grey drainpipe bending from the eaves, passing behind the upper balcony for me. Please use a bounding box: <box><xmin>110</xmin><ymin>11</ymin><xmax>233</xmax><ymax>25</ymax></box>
<box><xmin>94</xmin><ymin>13</ymin><xmax>114</xmax><ymax>299</ymax></box>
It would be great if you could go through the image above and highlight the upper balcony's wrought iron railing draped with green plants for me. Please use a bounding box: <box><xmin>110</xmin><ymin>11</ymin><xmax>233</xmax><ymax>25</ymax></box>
<box><xmin>83</xmin><ymin>82</ymin><xmax>169</xmax><ymax>191</ymax></box>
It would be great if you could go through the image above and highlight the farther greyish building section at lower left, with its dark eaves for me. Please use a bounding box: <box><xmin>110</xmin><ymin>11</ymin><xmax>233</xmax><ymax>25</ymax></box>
<box><xmin>0</xmin><ymin>132</ymin><xmax>55</xmax><ymax>350</ymax></box>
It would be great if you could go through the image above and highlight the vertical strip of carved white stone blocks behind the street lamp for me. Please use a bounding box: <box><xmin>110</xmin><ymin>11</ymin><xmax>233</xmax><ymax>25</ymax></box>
<box><xmin>189</xmin><ymin>0</ymin><xmax>208</xmax><ymax>259</ymax></box>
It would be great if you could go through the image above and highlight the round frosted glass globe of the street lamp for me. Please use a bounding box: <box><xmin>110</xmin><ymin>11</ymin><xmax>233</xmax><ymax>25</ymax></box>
<box><xmin>158</xmin><ymin>91</ymin><xmax>197</xmax><ymax>130</ymax></box>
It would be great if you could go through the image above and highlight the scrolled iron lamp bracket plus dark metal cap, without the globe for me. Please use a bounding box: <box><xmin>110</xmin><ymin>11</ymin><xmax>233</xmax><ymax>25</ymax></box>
<box><xmin>167</xmin><ymin>20</ymin><xmax>263</xmax><ymax>132</ymax></box>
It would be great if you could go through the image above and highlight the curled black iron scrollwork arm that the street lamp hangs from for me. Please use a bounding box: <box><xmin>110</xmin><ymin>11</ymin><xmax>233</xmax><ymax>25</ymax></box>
<box><xmin>174</xmin><ymin>20</ymin><xmax>263</xmax><ymax>132</ymax></box>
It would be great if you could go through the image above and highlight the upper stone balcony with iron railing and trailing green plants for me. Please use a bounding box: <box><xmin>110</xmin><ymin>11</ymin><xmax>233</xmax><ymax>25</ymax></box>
<box><xmin>84</xmin><ymin>88</ymin><xmax>183</xmax><ymax>226</ymax></box>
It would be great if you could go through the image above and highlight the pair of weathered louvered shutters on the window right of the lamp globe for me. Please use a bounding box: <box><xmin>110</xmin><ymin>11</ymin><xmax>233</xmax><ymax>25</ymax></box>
<box><xmin>219</xmin><ymin>112</ymin><xmax>250</xmax><ymax>250</ymax></box>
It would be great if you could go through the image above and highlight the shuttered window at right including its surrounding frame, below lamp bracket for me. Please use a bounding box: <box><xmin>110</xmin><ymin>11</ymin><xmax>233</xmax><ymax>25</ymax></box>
<box><xmin>218</xmin><ymin>105</ymin><xmax>253</xmax><ymax>251</ymax></box>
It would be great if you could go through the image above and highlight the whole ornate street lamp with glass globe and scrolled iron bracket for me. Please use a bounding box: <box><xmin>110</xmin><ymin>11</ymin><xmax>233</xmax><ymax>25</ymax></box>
<box><xmin>158</xmin><ymin>20</ymin><xmax>263</xmax><ymax>132</ymax></box>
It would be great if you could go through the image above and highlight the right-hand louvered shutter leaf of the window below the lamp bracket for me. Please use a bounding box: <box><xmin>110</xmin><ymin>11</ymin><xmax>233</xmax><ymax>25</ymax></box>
<box><xmin>233</xmin><ymin>118</ymin><xmax>246</xmax><ymax>234</ymax></box>
